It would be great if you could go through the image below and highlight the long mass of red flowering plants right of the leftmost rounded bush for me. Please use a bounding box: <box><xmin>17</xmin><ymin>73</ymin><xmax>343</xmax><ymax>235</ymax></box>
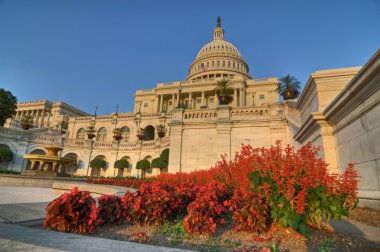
<box><xmin>46</xmin><ymin>141</ymin><xmax>358</xmax><ymax>236</ymax></box>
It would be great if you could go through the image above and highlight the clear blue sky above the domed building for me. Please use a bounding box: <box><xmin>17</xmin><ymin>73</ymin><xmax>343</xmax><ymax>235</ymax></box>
<box><xmin>0</xmin><ymin>0</ymin><xmax>380</xmax><ymax>114</ymax></box>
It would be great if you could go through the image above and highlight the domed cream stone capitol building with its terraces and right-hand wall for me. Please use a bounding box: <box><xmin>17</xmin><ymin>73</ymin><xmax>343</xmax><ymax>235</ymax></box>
<box><xmin>0</xmin><ymin>18</ymin><xmax>380</xmax><ymax>208</ymax></box>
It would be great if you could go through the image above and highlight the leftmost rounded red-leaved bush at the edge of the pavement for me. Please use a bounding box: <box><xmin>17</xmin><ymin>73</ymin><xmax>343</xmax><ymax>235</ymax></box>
<box><xmin>44</xmin><ymin>187</ymin><xmax>96</xmax><ymax>234</ymax></box>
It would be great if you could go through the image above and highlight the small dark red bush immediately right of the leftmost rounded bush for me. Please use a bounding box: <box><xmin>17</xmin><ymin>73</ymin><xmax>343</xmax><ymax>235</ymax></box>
<box><xmin>97</xmin><ymin>195</ymin><xmax>124</xmax><ymax>224</ymax></box>
